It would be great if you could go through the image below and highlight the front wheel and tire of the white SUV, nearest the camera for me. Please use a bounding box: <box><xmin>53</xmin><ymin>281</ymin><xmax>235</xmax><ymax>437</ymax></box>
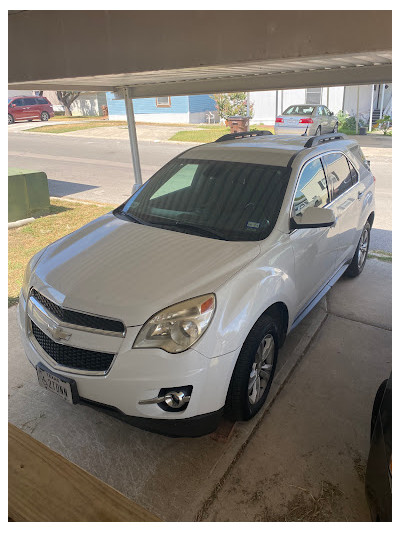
<box><xmin>225</xmin><ymin>315</ymin><xmax>279</xmax><ymax>422</ymax></box>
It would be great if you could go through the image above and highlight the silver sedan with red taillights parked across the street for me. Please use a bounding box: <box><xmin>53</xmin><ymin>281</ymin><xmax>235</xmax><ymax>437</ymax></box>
<box><xmin>275</xmin><ymin>104</ymin><xmax>338</xmax><ymax>135</ymax></box>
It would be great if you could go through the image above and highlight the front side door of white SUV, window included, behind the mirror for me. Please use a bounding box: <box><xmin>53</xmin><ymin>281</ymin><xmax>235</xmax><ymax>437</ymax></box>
<box><xmin>289</xmin><ymin>157</ymin><xmax>337</xmax><ymax>314</ymax></box>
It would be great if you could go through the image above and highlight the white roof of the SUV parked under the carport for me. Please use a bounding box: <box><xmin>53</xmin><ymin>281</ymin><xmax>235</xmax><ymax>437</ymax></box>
<box><xmin>178</xmin><ymin>134</ymin><xmax>357</xmax><ymax>166</ymax></box>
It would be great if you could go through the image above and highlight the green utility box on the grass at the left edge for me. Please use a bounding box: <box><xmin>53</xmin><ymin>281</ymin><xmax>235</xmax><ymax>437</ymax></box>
<box><xmin>8</xmin><ymin>168</ymin><xmax>50</xmax><ymax>222</ymax></box>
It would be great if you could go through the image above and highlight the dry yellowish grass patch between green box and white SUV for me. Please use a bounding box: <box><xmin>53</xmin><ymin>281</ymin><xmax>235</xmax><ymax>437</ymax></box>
<box><xmin>8</xmin><ymin>200</ymin><xmax>115</xmax><ymax>307</ymax></box>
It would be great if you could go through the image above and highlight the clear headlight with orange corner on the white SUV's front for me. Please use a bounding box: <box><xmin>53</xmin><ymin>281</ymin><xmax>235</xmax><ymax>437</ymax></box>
<box><xmin>133</xmin><ymin>294</ymin><xmax>216</xmax><ymax>353</ymax></box>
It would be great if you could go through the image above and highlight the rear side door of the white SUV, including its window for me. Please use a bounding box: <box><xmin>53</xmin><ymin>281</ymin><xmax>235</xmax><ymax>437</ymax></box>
<box><xmin>322</xmin><ymin>152</ymin><xmax>361</xmax><ymax>265</ymax></box>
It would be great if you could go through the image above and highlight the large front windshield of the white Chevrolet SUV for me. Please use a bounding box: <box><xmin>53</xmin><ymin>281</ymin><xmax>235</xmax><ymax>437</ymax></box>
<box><xmin>114</xmin><ymin>158</ymin><xmax>290</xmax><ymax>241</ymax></box>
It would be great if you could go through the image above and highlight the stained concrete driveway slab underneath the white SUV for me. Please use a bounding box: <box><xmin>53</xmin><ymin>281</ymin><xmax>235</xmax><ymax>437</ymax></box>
<box><xmin>9</xmin><ymin>259</ymin><xmax>391</xmax><ymax>521</ymax></box>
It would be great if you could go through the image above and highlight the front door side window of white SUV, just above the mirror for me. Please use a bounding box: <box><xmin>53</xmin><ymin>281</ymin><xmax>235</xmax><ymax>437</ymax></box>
<box><xmin>293</xmin><ymin>159</ymin><xmax>329</xmax><ymax>215</ymax></box>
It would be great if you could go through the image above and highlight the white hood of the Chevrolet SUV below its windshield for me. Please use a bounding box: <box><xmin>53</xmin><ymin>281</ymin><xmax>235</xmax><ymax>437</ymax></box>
<box><xmin>31</xmin><ymin>213</ymin><xmax>260</xmax><ymax>326</ymax></box>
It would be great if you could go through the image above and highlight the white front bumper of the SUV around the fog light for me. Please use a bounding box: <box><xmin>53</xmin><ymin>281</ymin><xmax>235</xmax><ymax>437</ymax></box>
<box><xmin>18</xmin><ymin>295</ymin><xmax>238</xmax><ymax>436</ymax></box>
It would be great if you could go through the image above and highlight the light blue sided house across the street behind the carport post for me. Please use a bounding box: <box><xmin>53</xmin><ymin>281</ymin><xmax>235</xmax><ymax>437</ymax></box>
<box><xmin>106</xmin><ymin>92</ymin><xmax>219</xmax><ymax>124</ymax></box>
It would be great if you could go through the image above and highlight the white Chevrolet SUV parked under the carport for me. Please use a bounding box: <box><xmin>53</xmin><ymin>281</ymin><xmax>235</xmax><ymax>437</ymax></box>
<box><xmin>19</xmin><ymin>132</ymin><xmax>374</xmax><ymax>436</ymax></box>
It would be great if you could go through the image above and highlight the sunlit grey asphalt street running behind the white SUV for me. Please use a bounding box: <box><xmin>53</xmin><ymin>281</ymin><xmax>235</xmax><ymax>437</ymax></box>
<box><xmin>9</xmin><ymin>130</ymin><xmax>392</xmax><ymax>252</ymax></box>
